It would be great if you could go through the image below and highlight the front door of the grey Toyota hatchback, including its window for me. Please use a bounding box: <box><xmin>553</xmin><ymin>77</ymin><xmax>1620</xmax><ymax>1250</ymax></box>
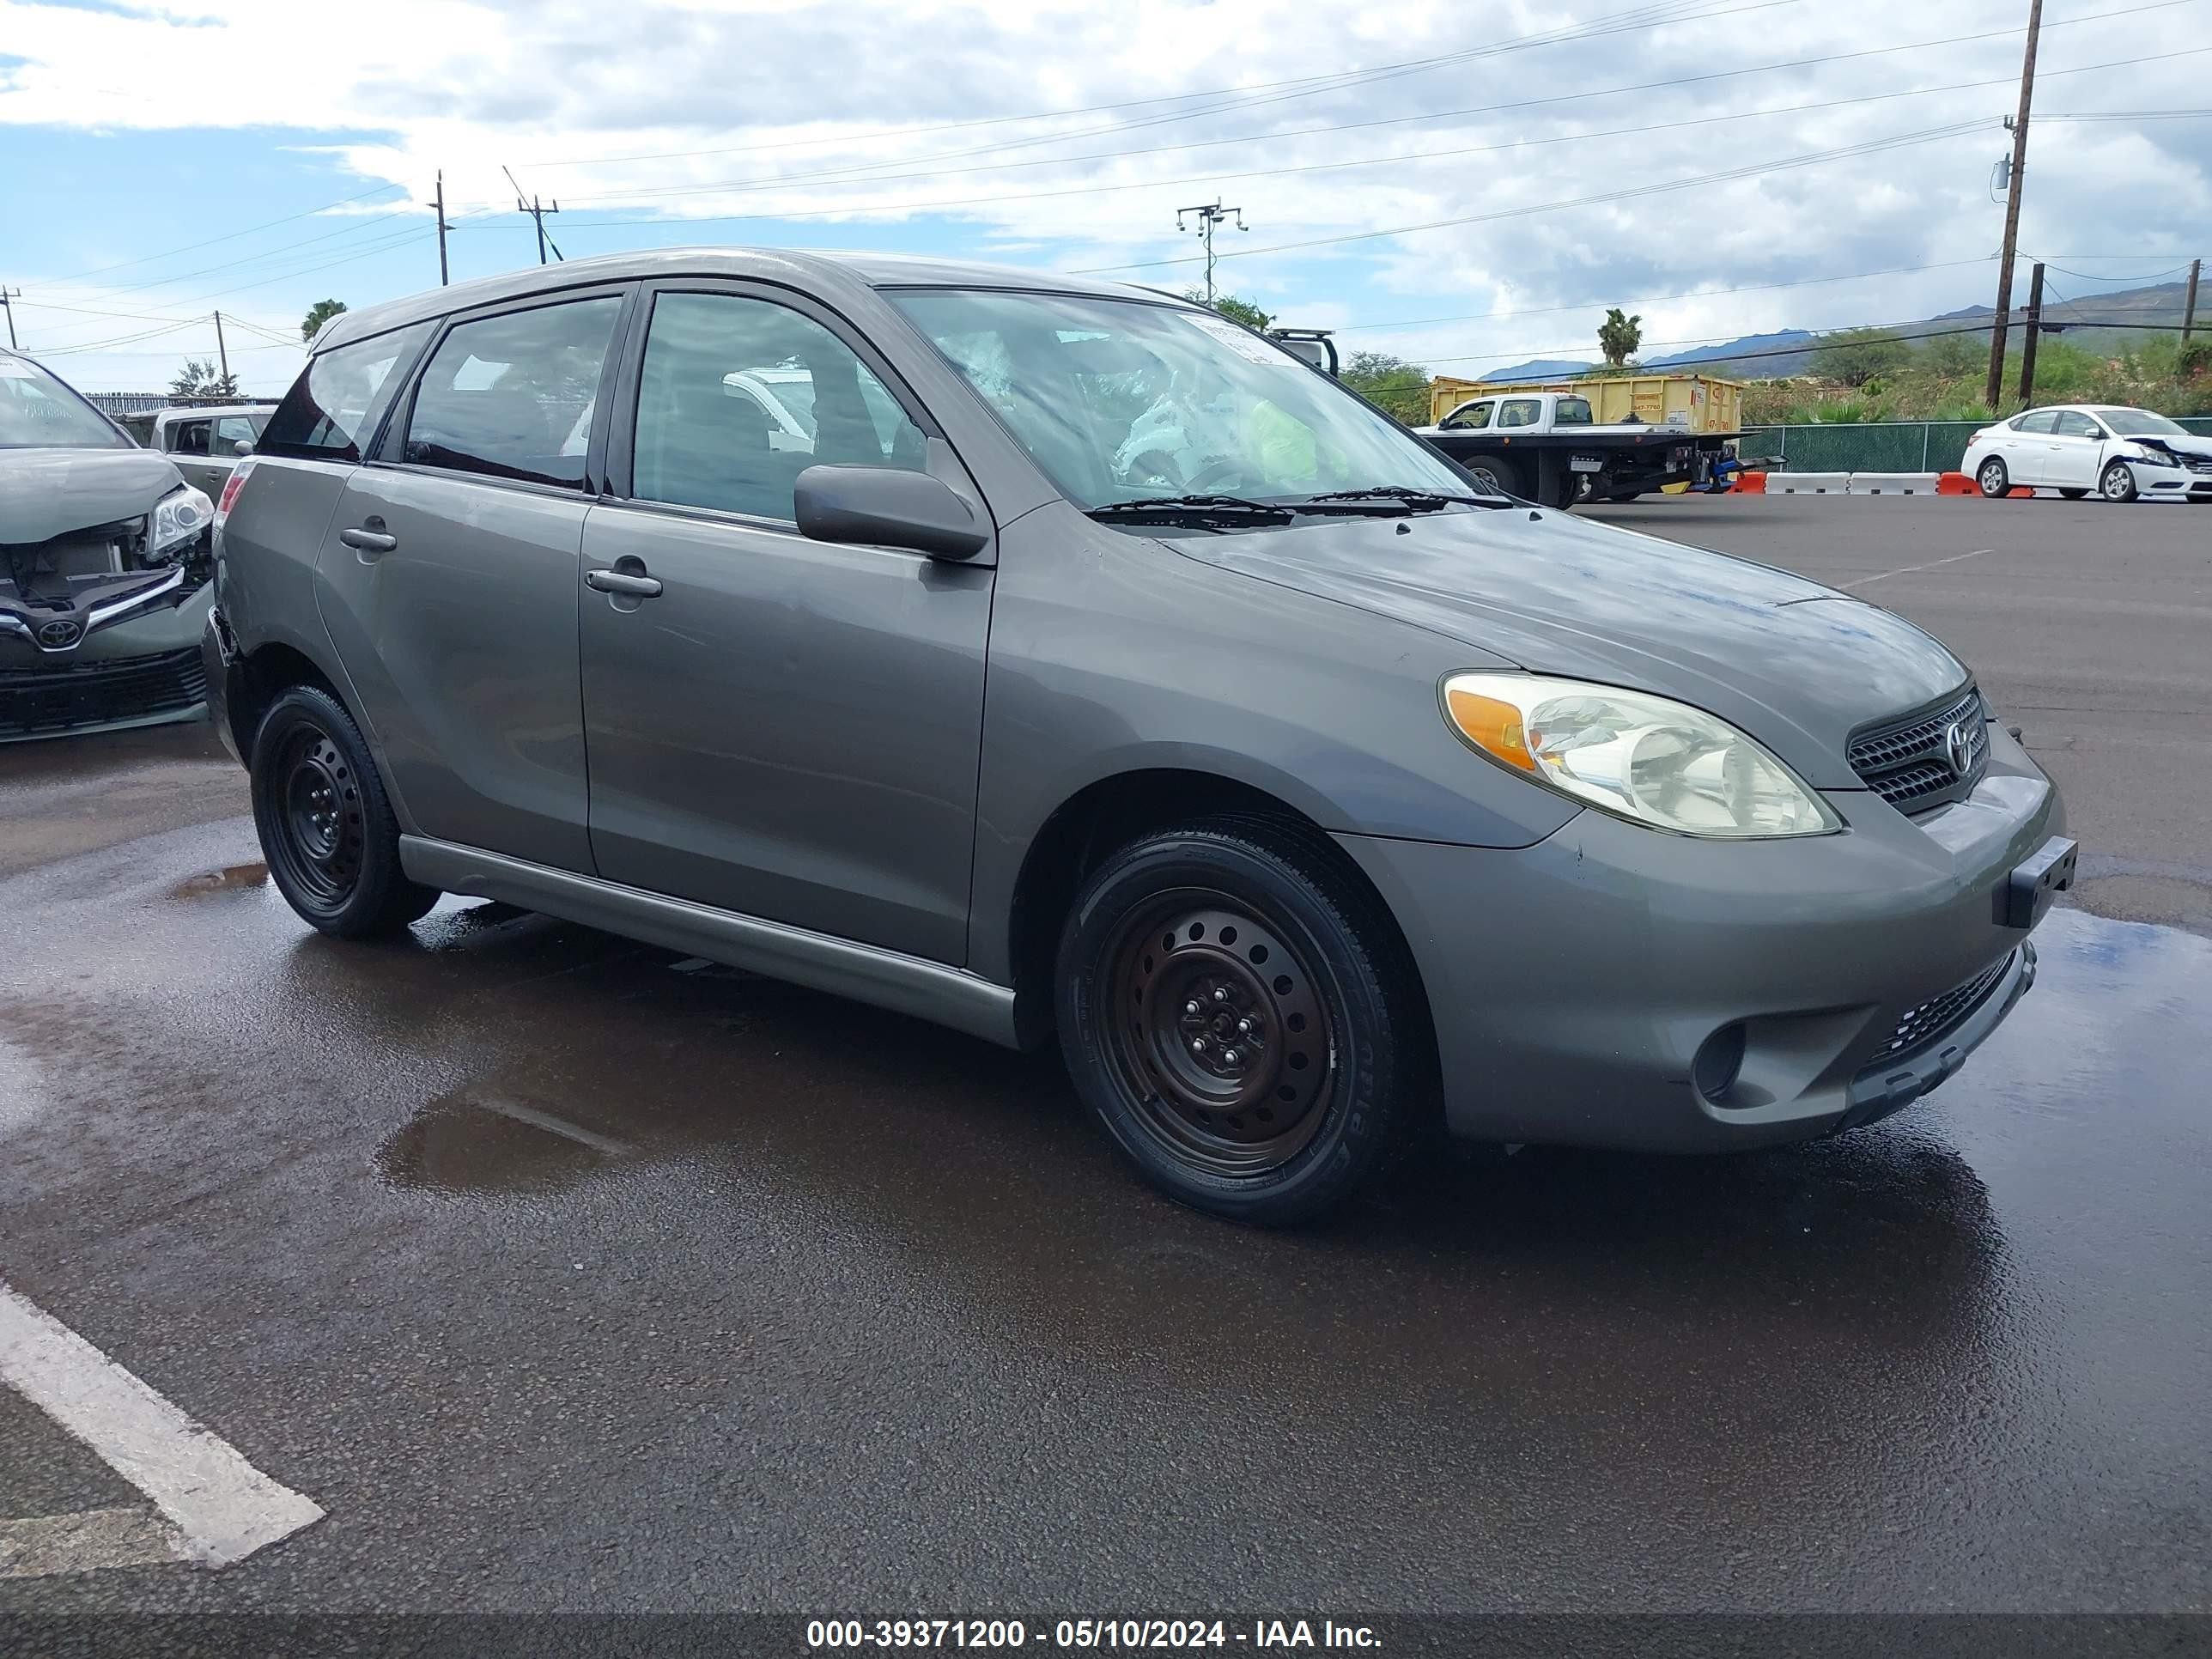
<box><xmin>580</xmin><ymin>285</ymin><xmax>994</xmax><ymax>964</ymax></box>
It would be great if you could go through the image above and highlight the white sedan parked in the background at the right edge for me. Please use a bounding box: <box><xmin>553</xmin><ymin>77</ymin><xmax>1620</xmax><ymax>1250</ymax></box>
<box><xmin>1962</xmin><ymin>403</ymin><xmax>2212</xmax><ymax>502</ymax></box>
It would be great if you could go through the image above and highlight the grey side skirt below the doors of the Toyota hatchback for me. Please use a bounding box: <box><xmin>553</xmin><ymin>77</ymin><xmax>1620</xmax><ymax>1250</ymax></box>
<box><xmin>400</xmin><ymin>836</ymin><xmax>1022</xmax><ymax>1048</ymax></box>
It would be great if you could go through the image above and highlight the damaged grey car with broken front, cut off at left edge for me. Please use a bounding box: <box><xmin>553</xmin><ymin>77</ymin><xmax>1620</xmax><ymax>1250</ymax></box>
<box><xmin>0</xmin><ymin>352</ymin><xmax>215</xmax><ymax>744</ymax></box>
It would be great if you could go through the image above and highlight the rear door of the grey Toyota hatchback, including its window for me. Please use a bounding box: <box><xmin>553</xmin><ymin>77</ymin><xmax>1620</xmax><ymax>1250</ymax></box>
<box><xmin>319</xmin><ymin>289</ymin><xmax>623</xmax><ymax>872</ymax></box>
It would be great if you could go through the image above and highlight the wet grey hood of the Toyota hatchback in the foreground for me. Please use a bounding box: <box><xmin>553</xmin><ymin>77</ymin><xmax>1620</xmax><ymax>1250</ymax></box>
<box><xmin>1172</xmin><ymin>507</ymin><xmax>1969</xmax><ymax>790</ymax></box>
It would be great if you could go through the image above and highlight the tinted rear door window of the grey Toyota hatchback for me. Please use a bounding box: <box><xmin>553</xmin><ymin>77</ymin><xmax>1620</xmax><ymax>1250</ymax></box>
<box><xmin>404</xmin><ymin>295</ymin><xmax>622</xmax><ymax>489</ymax></box>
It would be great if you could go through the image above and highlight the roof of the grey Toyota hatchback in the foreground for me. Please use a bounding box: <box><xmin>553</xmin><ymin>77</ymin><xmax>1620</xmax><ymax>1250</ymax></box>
<box><xmin>314</xmin><ymin>248</ymin><xmax>1186</xmax><ymax>352</ymax></box>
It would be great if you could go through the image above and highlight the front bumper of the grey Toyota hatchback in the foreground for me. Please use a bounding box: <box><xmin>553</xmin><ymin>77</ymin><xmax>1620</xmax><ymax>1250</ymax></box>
<box><xmin>1338</xmin><ymin>723</ymin><xmax>2063</xmax><ymax>1152</ymax></box>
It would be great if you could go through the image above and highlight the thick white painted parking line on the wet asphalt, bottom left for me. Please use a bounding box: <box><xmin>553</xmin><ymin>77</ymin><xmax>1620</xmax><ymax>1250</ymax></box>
<box><xmin>0</xmin><ymin>1283</ymin><xmax>323</xmax><ymax>1571</ymax></box>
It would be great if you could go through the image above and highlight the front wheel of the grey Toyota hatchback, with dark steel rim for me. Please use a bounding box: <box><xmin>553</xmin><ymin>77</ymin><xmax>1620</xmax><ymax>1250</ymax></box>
<box><xmin>1055</xmin><ymin>818</ymin><xmax>1437</xmax><ymax>1225</ymax></box>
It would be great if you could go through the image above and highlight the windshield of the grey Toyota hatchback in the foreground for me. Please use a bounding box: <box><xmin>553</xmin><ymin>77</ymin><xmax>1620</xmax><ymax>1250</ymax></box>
<box><xmin>887</xmin><ymin>289</ymin><xmax>1468</xmax><ymax>508</ymax></box>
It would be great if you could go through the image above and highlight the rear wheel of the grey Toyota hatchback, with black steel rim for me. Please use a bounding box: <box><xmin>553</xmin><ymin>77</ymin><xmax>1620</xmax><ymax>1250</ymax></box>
<box><xmin>250</xmin><ymin>686</ymin><xmax>438</xmax><ymax>938</ymax></box>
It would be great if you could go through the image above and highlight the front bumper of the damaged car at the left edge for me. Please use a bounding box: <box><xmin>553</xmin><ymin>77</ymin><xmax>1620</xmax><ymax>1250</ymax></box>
<box><xmin>0</xmin><ymin>584</ymin><xmax>212</xmax><ymax>744</ymax></box>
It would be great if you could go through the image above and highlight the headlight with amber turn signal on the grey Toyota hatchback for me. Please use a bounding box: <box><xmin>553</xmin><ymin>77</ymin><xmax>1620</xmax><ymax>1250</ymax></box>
<box><xmin>1444</xmin><ymin>675</ymin><xmax>1843</xmax><ymax>841</ymax></box>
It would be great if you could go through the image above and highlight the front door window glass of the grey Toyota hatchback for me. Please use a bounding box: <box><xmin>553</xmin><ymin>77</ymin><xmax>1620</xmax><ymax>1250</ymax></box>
<box><xmin>630</xmin><ymin>295</ymin><xmax>927</xmax><ymax>525</ymax></box>
